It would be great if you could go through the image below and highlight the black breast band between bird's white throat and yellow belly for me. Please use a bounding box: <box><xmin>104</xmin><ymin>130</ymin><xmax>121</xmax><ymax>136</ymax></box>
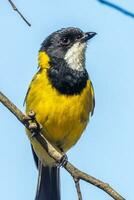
<box><xmin>48</xmin><ymin>58</ymin><xmax>88</xmax><ymax>95</ymax></box>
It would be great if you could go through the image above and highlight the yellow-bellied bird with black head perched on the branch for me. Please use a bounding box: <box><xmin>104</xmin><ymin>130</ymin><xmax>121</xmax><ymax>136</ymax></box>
<box><xmin>25</xmin><ymin>27</ymin><xmax>96</xmax><ymax>200</ymax></box>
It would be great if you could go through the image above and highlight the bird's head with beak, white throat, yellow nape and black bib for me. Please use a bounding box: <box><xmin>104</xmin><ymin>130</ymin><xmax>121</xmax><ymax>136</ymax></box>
<box><xmin>39</xmin><ymin>28</ymin><xmax>96</xmax><ymax>95</ymax></box>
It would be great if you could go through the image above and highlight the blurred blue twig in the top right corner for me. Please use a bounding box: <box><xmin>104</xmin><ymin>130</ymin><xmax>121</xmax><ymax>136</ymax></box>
<box><xmin>98</xmin><ymin>0</ymin><xmax>134</xmax><ymax>18</ymax></box>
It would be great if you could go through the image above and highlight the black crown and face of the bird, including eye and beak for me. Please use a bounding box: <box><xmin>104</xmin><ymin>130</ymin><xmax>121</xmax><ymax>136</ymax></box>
<box><xmin>40</xmin><ymin>27</ymin><xmax>96</xmax><ymax>65</ymax></box>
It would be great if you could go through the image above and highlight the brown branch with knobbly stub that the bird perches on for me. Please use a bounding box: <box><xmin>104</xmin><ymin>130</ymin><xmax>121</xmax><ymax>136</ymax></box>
<box><xmin>0</xmin><ymin>92</ymin><xmax>125</xmax><ymax>200</ymax></box>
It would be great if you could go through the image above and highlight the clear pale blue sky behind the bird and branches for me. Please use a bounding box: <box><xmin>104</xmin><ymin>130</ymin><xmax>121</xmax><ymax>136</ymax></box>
<box><xmin>0</xmin><ymin>0</ymin><xmax>134</xmax><ymax>200</ymax></box>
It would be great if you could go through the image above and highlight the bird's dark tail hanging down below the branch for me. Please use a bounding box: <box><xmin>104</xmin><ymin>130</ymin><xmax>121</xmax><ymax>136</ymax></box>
<box><xmin>35</xmin><ymin>163</ymin><xmax>60</xmax><ymax>200</ymax></box>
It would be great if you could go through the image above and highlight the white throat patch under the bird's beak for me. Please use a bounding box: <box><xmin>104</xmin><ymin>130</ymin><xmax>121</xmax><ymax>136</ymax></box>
<box><xmin>64</xmin><ymin>42</ymin><xmax>86</xmax><ymax>71</ymax></box>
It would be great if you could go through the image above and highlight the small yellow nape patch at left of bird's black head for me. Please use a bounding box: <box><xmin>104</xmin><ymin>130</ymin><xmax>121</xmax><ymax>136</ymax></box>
<box><xmin>38</xmin><ymin>51</ymin><xmax>50</xmax><ymax>69</ymax></box>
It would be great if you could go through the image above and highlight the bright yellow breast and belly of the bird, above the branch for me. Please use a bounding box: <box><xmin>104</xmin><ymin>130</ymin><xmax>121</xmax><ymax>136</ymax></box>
<box><xmin>26</xmin><ymin>69</ymin><xmax>93</xmax><ymax>164</ymax></box>
